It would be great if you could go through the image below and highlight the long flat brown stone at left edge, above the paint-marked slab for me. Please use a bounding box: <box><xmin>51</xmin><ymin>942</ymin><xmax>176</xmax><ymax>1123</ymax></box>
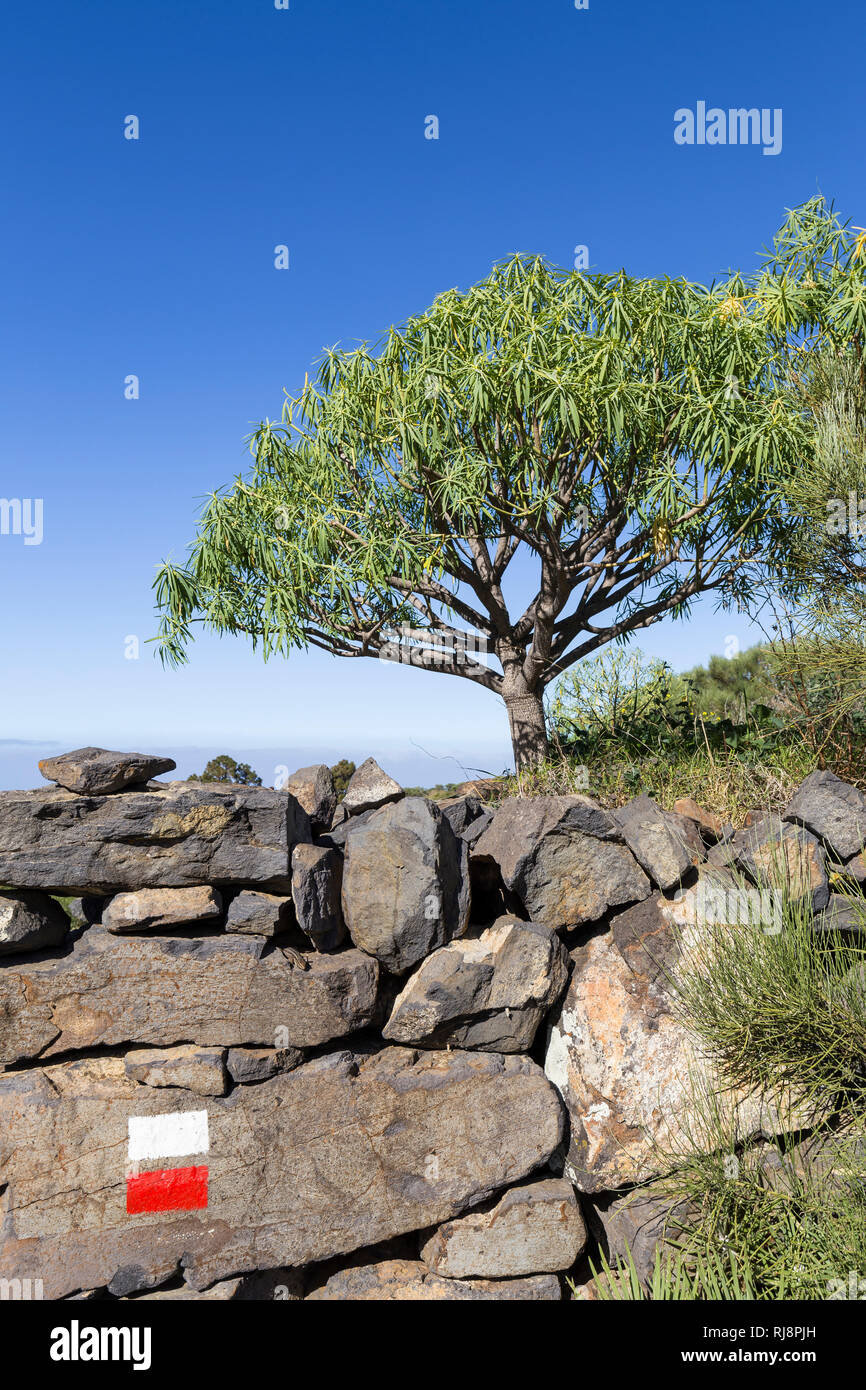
<box><xmin>0</xmin><ymin>927</ymin><xmax>378</xmax><ymax>1063</ymax></box>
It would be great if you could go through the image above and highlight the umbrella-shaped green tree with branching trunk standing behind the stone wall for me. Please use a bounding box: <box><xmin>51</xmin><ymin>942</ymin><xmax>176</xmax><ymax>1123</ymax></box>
<box><xmin>154</xmin><ymin>232</ymin><xmax>803</xmax><ymax>767</ymax></box>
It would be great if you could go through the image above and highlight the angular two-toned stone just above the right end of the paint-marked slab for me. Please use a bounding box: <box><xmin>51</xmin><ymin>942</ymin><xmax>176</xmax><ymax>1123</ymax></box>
<box><xmin>382</xmin><ymin>917</ymin><xmax>569</xmax><ymax>1052</ymax></box>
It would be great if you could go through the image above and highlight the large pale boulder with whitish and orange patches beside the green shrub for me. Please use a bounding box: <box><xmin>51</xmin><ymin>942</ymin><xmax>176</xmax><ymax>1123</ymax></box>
<box><xmin>545</xmin><ymin>888</ymin><xmax>813</xmax><ymax>1193</ymax></box>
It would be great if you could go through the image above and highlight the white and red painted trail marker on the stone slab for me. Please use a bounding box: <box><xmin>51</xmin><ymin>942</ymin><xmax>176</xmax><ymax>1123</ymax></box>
<box><xmin>126</xmin><ymin>1111</ymin><xmax>210</xmax><ymax>1216</ymax></box>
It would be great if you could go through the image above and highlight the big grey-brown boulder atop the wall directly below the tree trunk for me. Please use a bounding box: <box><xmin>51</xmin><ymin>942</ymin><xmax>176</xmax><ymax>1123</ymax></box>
<box><xmin>473</xmin><ymin>796</ymin><xmax>651</xmax><ymax>930</ymax></box>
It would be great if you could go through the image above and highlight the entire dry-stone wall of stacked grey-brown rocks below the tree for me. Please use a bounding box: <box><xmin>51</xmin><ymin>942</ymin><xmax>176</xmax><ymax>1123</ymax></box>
<box><xmin>0</xmin><ymin>748</ymin><xmax>866</xmax><ymax>1301</ymax></box>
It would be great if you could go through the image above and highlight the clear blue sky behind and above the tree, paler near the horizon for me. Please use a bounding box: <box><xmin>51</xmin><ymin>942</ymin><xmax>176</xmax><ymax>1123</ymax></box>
<box><xmin>0</xmin><ymin>0</ymin><xmax>866</xmax><ymax>787</ymax></box>
